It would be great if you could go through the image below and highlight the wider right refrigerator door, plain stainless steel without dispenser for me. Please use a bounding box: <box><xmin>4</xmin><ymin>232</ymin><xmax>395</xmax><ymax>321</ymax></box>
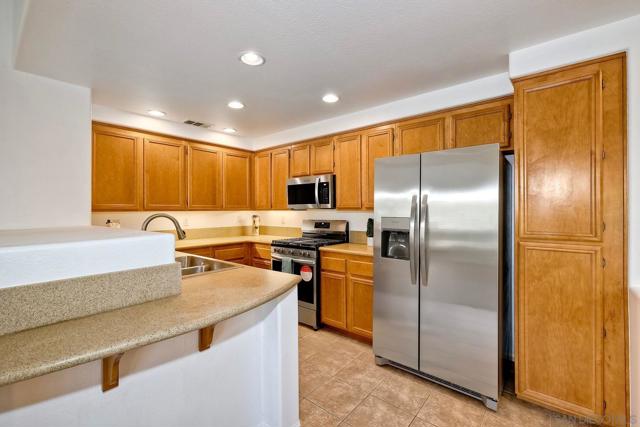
<box><xmin>418</xmin><ymin>144</ymin><xmax>501</xmax><ymax>400</ymax></box>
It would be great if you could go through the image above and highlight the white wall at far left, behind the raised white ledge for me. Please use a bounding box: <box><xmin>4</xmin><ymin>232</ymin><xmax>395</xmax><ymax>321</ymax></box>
<box><xmin>0</xmin><ymin>1</ymin><xmax>91</xmax><ymax>229</ymax></box>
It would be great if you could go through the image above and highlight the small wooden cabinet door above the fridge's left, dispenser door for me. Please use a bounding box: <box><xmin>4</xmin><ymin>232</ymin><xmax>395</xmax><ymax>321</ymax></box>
<box><xmin>396</xmin><ymin>117</ymin><xmax>445</xmax><ymax>155</ymax></box>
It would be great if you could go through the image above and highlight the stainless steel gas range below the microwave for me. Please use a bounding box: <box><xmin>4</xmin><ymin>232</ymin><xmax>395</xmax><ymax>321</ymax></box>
<box><xmin>271</xmin><ymin>219</ymin><xmax>349</xmax><ymax>330</ymax></box>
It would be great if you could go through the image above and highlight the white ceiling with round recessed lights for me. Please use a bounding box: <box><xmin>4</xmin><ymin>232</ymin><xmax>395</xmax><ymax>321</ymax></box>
<box><xmin>16</xmin><ymin>0</ymin><xmax>640</xmax><ymax>137</ymax></box>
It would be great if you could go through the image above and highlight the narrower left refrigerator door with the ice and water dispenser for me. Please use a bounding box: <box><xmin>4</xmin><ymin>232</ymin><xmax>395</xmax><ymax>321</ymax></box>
<box><xmin>373</xmin><ymin>154</ymin><xmax>420</xmax><ymax>369</ymax></box>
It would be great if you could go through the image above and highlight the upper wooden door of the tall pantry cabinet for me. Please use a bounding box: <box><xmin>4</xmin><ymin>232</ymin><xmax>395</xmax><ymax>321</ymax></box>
<box><xmin>516</xmin><ymin>65</ymin><xmax>602</xmax><ymax>240</ymax></box>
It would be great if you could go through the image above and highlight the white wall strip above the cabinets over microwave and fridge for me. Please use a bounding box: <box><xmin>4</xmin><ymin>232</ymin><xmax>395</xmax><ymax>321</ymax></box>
<box><xmin>253</xmin><ymin>73</ymin><xmax>513</xmax><ymax>150</ymax></box>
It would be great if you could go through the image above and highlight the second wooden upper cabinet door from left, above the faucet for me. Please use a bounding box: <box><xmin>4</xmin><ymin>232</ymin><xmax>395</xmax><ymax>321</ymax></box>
<box><xmin>144</xmin><ymin>137</ymin><xmax>187</xmax><ymax>210</ymax></box>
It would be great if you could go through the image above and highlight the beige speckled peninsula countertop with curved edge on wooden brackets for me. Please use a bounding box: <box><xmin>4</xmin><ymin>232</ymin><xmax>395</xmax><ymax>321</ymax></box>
<box><xmin>0</xmin><ymin>256</ymin><xmax>300</xmax><ymax>386</ymax></box>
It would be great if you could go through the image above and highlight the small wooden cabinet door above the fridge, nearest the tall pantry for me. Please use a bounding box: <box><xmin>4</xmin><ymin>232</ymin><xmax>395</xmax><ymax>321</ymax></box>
<box><xmin>450</xmin><ymin>100</ymin><xmax>511</xmax><ymax>149</ymax></box>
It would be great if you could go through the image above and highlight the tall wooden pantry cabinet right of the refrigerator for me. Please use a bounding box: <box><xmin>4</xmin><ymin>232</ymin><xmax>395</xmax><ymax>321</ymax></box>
<box><xmin>514</xmin><ymin>55</ymin><xmax>628</xmax><ymax>425</ymax></box>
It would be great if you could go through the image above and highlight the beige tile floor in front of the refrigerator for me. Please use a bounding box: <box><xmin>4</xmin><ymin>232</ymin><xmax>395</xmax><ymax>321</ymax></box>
<box><xmin>299</xmin><ymin>326</ymin><xmax>582</xmax><ymax>427</ymax></box>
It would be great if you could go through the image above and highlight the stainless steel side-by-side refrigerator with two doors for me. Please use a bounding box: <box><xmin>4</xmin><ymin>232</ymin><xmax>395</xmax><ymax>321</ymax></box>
<box><xmin>373</xmin><ymin>144</ymin><xmax>502</xmax><ymax>410</ymax></box>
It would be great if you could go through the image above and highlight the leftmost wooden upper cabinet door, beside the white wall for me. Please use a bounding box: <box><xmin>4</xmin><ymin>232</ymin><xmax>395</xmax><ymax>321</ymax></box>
<box><xmin>91</xmin><ymin>125</ymin><xmax>143</xmax><ymax>211</ymax></box>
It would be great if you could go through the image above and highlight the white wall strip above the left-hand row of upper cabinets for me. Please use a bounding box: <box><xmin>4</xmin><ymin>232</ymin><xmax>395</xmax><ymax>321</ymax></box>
<box><xmin>91</xmin><ymin>104</ymin><xmax>252</xmax><ymax>150</ymax></box>
